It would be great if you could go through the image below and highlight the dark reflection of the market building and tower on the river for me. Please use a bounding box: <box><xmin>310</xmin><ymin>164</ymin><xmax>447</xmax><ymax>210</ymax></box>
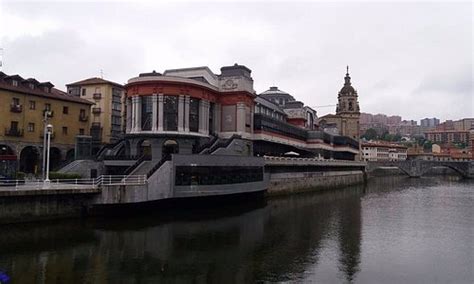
<box><xmin>0</xmin><ymin>176</ymin><xmax>472</xmax><ymax>283</ymax></box>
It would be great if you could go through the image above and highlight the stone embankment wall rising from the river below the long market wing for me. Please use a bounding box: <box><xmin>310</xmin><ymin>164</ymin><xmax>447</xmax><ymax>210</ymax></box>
<box><xmin>267</xmin><ymin>171</ymin><xmax>364</xmax><ymax>196</ymax></box>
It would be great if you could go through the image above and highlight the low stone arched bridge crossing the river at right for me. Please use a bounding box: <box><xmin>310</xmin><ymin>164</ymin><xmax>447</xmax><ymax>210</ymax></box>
<box><xmin>366</xmin><ymin>160</ymin><xmax>474</xmax><ymax>178</ymax></box>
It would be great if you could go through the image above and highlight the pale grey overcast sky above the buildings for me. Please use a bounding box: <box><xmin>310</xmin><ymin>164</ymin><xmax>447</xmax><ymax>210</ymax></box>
<box><xmin>0</xmin><ymin>0</ymin><xmax>474</xmax><ymax>120</ymax></box>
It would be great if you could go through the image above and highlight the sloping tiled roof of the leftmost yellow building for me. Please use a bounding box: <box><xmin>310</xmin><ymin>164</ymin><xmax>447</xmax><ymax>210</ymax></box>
<box><xmin>0</xmin><ymin>75</ymin><xmax>93</xmax><ymax>105</ymax></box>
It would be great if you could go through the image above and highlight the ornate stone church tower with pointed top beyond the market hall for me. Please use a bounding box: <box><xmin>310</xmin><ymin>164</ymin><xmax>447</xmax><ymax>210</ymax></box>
<box><xmin>336</xmin><ymin>66</ymin><xmax>360</xmax><ymax>141</ymax></box>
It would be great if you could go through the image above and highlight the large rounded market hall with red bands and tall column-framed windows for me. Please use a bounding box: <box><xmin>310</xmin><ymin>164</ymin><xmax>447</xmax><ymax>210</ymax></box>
<box><xmin>99</xmin><ymin>64</ymin><xmax>358</xmax><ymax>172</ymax></box>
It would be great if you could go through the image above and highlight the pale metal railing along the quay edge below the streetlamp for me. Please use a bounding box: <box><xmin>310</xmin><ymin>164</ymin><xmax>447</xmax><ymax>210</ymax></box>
<box><xmin>0</xmin><ymin>175</ymin><xmax>147</xmax><ymax>191</ymax></box>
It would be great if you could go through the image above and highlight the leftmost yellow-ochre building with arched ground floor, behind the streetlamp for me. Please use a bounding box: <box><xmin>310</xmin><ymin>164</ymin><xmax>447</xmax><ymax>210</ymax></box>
<box><xmin>0</xmin><ymin>72</ymin><xmax>91</xmax><ymax>175</ymax></box>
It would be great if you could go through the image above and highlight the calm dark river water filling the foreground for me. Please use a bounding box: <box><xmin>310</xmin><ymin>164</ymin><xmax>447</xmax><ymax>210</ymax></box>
<box><xmin>0</xmin><ymin>178</ymin><xmax>474</xmax><ymax>283</ymax></box>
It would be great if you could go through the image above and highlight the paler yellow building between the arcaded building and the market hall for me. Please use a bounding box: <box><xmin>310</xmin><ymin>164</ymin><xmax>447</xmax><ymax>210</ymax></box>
<box><xmin>66</xmin><ymin>78</ymin><xmax>125</xmax><ymax>150</ymax></box>
